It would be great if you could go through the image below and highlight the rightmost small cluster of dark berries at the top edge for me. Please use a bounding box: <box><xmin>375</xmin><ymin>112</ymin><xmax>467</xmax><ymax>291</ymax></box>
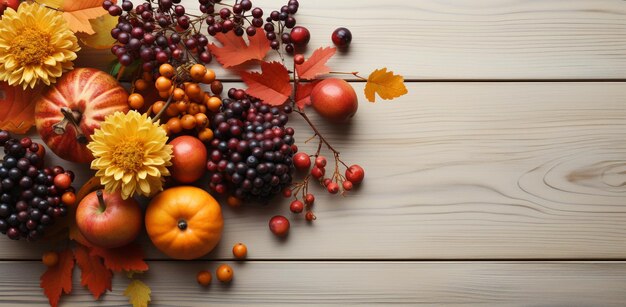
<box><xmin>263</xmin><ymin>0</ymin><xmax>300</xmax><ymax>54</ymax></box>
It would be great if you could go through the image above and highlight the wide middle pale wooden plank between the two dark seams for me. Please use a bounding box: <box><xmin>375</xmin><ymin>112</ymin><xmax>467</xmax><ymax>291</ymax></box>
<box><xmin>0</xmin><ymin>83</ymin><xmax>626</xmax><ymax>259</ymax></box>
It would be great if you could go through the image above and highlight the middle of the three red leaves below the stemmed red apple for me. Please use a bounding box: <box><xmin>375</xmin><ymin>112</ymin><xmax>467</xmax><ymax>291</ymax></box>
<box><xmin>74</xmin><ymin>244</ymin><xmax>113</xmax><ymax>299</ymax></box>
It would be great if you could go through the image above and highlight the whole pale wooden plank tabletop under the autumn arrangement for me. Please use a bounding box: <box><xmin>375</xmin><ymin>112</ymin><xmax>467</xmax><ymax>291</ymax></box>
<box><xmin>0</xmin><ymin>0</ymin><xmax>626</xmax><ymax>306</ymax></box>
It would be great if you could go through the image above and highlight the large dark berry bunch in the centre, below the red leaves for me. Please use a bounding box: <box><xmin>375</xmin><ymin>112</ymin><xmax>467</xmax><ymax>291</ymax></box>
<box><xmin>207</xmin><ymin>89</ymin><xmax>297</xmax><ymax>203</ymax></box>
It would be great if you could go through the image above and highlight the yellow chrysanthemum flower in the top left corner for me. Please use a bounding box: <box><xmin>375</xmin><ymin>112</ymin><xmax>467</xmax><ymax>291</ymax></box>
<box><xmin>0</xmin><ymin>3</ymin><xmax>80</xmax><ymax>89</ymax></box>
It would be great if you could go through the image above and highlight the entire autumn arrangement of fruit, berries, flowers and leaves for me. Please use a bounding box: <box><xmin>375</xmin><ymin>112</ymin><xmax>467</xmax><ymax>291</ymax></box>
<box><xmin>0</xmin><ymin>0</ymin><xmax>407</xmax><ymax>306</ymax></box>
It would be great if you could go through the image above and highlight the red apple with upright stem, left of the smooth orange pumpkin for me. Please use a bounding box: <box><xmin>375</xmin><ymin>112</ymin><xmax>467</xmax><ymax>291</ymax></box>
<box><xmin>76</xmin><ymin>190</ymin><xmax>143</xmax><ymax>248</ymax></box>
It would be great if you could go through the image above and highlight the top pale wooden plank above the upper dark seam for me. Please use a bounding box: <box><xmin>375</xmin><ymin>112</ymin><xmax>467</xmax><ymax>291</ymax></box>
<box><xmin>78</xmin><ymin>0</ymin><xmax>626</xmax><ymax>80</ymax></box>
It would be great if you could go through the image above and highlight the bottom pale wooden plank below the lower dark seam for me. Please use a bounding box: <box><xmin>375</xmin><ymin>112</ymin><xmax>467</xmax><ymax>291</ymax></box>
<box><xmin>0</xmin><ymin>261</ymin><xmax>626</xmax><ymax>307</ymax></box>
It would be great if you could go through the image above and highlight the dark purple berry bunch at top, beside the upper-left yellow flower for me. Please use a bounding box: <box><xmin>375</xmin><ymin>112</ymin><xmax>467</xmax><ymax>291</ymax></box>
<box><xmin>102</xmin><ymin>0</ymin><xmax>213</xmax><ymax>72</ymax></box>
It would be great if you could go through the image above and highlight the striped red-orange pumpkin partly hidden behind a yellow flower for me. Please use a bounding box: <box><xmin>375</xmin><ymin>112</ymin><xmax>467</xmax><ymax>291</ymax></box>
<box><xmin>35</xmin><ymin>68</ymin><xmax>129</xmax><ymax>163</ymax></box>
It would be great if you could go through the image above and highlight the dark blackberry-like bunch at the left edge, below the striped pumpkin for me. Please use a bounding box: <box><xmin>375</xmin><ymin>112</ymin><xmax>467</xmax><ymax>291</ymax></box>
<box><xmin>0</xmin><ymin>130</ymin><xmax>74</xmax><ymax>241</ymax></box>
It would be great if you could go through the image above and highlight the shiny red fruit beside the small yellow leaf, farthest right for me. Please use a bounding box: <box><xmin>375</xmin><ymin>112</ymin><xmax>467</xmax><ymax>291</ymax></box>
<box><xmin>311</xmin><ymin>78</ymin><xmax>359</xmax><ymax>122</ymax></box>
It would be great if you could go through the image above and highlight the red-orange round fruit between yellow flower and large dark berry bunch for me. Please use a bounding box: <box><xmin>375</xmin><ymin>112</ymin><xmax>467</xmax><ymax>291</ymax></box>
<box><xmin>170</xmin><ymin>135</ymin><xmax>207</xmax><ymax>183</ymax></box>
